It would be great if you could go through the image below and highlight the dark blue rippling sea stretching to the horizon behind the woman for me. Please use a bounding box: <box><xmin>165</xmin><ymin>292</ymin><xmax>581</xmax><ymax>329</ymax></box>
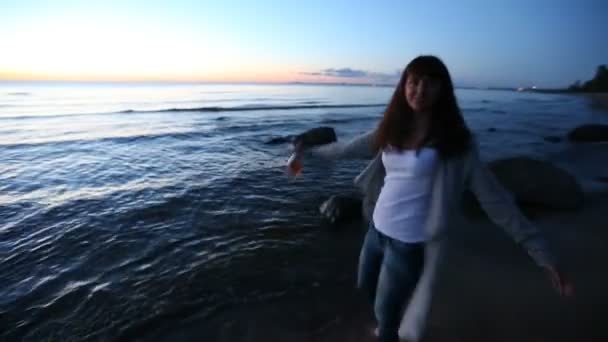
<box><xmin>0</xmin><ymin>82</ymin><xmax>608</xmax><ymax>341</ymax></box>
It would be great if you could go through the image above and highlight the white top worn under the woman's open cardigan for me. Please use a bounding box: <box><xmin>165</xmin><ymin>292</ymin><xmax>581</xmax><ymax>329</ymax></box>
<box><xmin>373</xmin><ymin>147</ymin><xmax>439</xmax><ymax>243</ymax></box>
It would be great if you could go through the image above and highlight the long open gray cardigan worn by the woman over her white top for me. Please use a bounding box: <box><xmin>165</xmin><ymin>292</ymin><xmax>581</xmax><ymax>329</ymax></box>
<box><xmin>310</xmin><ymin>131</ymin><xmax>555</xmax><ymax>341</ymax></box>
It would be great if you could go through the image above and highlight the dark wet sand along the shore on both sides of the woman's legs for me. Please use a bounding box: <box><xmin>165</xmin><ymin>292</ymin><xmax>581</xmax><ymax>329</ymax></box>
<box><xmin>157</xmin><ymin>192</ymin><xmax>608</xmax><ymax>342</ymax></box>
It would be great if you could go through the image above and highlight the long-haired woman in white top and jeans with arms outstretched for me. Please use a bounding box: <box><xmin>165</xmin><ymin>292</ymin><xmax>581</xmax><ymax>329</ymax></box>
<box><xmin>290</xmin><ymin>56</ymin><xmax>571</xmax><ymax>341</ymax></box>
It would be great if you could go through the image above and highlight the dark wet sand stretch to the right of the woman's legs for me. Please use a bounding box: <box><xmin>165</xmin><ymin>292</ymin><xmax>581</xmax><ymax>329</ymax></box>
<box><xmin>427</xmin><ymin>193</ymin><xmax>608</xmax><ymax>341</ymax></box>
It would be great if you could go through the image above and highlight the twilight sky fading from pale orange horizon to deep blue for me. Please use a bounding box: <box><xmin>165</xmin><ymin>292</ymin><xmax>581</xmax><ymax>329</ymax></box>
<box><xmin>0</xmin><ymin>0</ymin><xmax>608</xmax><ymax>88</ymax></box>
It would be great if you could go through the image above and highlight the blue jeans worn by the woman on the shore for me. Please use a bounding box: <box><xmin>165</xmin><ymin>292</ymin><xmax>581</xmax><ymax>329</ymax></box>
<box><xmin>357</xmin><ymin>222</ymin><xmax>424</xmax><ymax>342</ymax></box>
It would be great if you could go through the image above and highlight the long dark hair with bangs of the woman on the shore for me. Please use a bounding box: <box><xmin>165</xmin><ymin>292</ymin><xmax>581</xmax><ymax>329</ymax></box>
<box><xmin>374</xmin><ymin>56</ymin><xmax>471</xmax><ymax>158</ymax></box>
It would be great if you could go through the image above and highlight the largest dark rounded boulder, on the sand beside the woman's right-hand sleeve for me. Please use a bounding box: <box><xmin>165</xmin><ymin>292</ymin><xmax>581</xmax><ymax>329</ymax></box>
<box><xmin>488</xmin><ymin>157</ymin><xmax>583</xmax><ymax>209</ymax></box>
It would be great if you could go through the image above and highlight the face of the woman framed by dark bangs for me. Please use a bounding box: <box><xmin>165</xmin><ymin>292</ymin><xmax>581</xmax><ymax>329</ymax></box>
<box><xmin>405</xmin><ymin>74</ymin><xmax>441</xmax><ymax>112</ymax></box>
